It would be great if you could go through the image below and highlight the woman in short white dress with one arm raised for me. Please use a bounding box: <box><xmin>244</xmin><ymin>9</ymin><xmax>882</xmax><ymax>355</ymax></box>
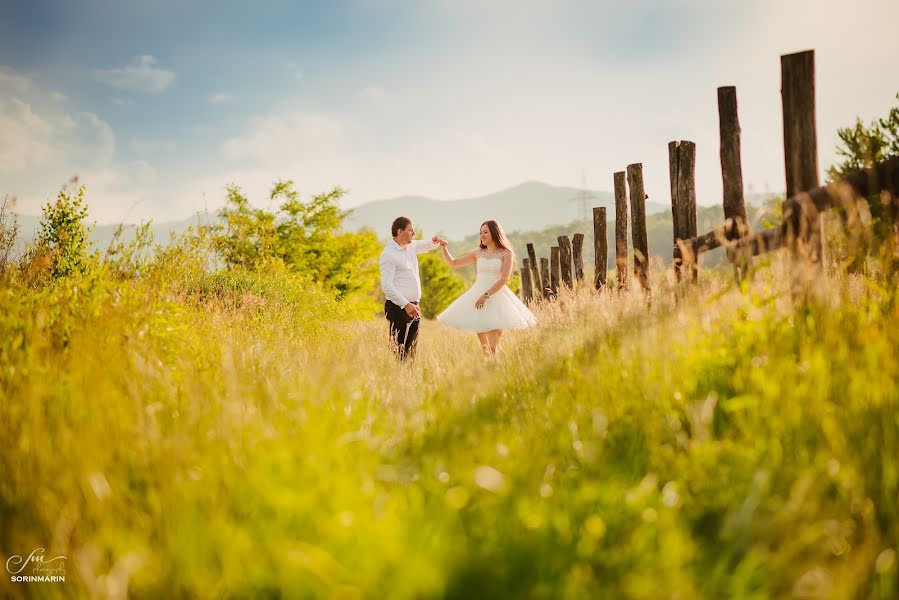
<box><xmin>437</xmin><ymin>221</ymin><xmax>537</xmax><ymax>356</ymax></box>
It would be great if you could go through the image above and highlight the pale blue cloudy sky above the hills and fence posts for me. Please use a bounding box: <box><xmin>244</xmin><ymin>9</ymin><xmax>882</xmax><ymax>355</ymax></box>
<box><xmin>0</xmin><ymin>0</ymin><xmax>899</xmax><ymax>223</ymax></box>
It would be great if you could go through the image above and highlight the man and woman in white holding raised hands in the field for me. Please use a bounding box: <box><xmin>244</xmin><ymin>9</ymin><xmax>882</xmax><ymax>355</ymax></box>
<box><xmin>379</xmin><ymin>217</ymin><xmax>537</xmax><ymax>359</ymax></box>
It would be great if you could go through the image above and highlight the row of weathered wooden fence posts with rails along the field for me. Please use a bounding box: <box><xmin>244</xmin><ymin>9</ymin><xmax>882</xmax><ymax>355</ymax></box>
<box><xmin>521</xmin><ymin>50</ymin><xmax>899</xmax><ymax>301</ymax></box>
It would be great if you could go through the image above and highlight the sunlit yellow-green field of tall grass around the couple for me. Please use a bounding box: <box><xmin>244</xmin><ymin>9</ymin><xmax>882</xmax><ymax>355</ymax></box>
<box><xmin>0</xmin><ymin>258</ymin><xmax>899</xmax><ymax>598</ymax></box>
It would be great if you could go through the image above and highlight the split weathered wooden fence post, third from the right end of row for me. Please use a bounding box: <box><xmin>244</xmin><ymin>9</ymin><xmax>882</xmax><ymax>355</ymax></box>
<box><xmin>668</xmin><ymin>141</ymin><xmax>697</xmax><ymax>282</ymax></box>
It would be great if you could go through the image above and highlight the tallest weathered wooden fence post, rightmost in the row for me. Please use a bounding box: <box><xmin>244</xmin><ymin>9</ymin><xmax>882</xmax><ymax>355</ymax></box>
<box><xmin>780</xmin><ymin>50</ymin><xmax>821</xmax><ymax>270</ymax></box>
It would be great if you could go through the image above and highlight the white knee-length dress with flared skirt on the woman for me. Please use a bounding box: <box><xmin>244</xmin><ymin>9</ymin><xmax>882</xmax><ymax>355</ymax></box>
<box><xmin>437</xmin><ymin>250</ymin><xmax>537</xmax><ymax>333</ymax></box>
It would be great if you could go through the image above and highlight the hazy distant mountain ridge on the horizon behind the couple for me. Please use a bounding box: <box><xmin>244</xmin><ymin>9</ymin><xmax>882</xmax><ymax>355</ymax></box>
<box><xmin>344</xmin><ymin>181</ymin><xmax>670</xmax><ymax>240</ymax></box>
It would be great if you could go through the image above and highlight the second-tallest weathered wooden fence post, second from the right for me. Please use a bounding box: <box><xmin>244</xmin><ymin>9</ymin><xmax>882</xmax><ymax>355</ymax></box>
<box><xmin>718</xmin><ymin>86</ymin><xmax>751</xmax><ymax>279</ymax></box>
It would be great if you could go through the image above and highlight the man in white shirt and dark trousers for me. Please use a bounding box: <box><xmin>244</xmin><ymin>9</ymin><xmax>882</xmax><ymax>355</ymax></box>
<box><xmin>378</xmin><ymin>217</ymin><xmax>443</xmax><ymax>359</ymax></box>
